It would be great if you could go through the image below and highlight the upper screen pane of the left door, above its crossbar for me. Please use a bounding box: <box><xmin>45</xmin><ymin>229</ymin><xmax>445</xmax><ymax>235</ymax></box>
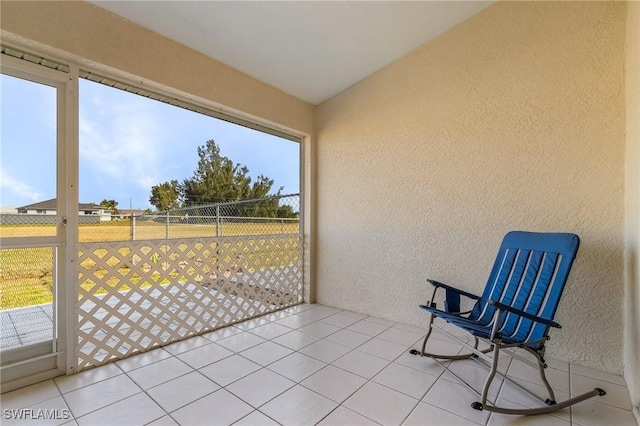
<box><xmin>0</xmin><ymin>74</ymin><xmax>57</xmax><ymax>237</ymax></box>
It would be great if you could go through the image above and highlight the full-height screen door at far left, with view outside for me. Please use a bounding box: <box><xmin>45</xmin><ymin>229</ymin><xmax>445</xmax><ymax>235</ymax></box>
<box><xmin>0</xmin><ymin>58</ymin><xmax>63</xmax><ymax>374</ymax></box>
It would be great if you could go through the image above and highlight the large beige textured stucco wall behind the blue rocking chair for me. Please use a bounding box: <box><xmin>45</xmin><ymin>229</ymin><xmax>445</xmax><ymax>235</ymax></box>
<box><xmin>316</xmin><ymin>2</ymin><xmax>626</xmax><ymax>373</ymax></box>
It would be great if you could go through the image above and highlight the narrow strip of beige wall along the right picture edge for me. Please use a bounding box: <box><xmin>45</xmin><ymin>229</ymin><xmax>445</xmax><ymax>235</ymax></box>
<box><xmin>624</xmin><ymin>2</ymin><xmax>640</xmax><ymax>422</ymax></box>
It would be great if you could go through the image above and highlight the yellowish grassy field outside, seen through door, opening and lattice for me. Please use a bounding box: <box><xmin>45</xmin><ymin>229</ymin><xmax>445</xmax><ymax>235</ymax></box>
<box><xmin>0</xmin><ymin>221</ymin><xmax>298</xmax><ymax>310</ymax></box>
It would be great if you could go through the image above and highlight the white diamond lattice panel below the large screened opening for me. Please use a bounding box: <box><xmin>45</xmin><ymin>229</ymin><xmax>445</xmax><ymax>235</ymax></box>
<box><xmin>75</xmin><ymin>234</ymin><xmax>303</xmax><ymax>371</ymax></box>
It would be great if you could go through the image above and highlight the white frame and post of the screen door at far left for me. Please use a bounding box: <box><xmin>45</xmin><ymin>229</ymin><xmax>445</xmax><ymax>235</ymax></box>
<box><xmin>0</xmin><ymin>55</ymin><xmax>78</xmax><ymax>392</ymax></box>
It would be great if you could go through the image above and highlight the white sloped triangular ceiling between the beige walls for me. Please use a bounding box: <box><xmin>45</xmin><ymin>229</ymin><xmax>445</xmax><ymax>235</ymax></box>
<box><xmin>91</xmin><ymin>0</ymin><xmax>494</xmax><ymax>105</ymax></box>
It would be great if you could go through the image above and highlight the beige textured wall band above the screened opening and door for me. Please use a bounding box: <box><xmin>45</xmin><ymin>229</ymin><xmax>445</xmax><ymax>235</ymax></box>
<box><xmin>0</xmin><ymin>1</ymin><xmax>313</xmax><ymax>133</ymax></box>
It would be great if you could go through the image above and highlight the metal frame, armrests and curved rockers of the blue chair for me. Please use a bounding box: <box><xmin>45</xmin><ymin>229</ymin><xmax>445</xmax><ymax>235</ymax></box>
<box><xmin>410</xmin><ymin>280</ymin><xmax>606</xmax><ymax>415</ymax></box>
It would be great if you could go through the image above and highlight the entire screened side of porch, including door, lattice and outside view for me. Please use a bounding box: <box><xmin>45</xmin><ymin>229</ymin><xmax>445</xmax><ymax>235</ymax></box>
<box><xmin>0</xmin><ymin>47</ymin><xmax>304</xmax><ymax>378</ymax></box>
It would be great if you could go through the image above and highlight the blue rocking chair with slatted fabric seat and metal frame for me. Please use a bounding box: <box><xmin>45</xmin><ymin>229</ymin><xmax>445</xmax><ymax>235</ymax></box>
<box><xmin>411</xmin><ymin>231</ymin><xmax>606</xmax><ymax>415</ymax></box>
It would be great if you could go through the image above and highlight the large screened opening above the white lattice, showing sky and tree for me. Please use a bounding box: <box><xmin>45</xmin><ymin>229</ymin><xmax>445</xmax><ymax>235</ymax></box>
<box><xmin>79</xmin><ymin>77</ymin><xmax>300</xmax><ymax>241</ymax></box>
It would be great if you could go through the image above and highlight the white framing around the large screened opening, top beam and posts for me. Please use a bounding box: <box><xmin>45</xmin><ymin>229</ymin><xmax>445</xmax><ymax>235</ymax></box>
<box><xmin>0</xmin><ymin>40</ymin><xmax>313</xmax><ymax>389</ymax></box>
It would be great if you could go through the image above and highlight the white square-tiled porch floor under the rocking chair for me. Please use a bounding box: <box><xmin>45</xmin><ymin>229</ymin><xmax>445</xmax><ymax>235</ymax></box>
<box><xmin>1</xmin><ymin>304</ymin><xmax>636</xmax><ymax>426</ymax></box>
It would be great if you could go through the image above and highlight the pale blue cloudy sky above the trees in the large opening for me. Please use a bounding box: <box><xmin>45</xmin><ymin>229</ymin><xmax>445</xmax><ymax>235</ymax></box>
<box><xmin>80</xmin><ymin>81</ymin><xmax>299</xmax><ymax>206</ymax></box>
